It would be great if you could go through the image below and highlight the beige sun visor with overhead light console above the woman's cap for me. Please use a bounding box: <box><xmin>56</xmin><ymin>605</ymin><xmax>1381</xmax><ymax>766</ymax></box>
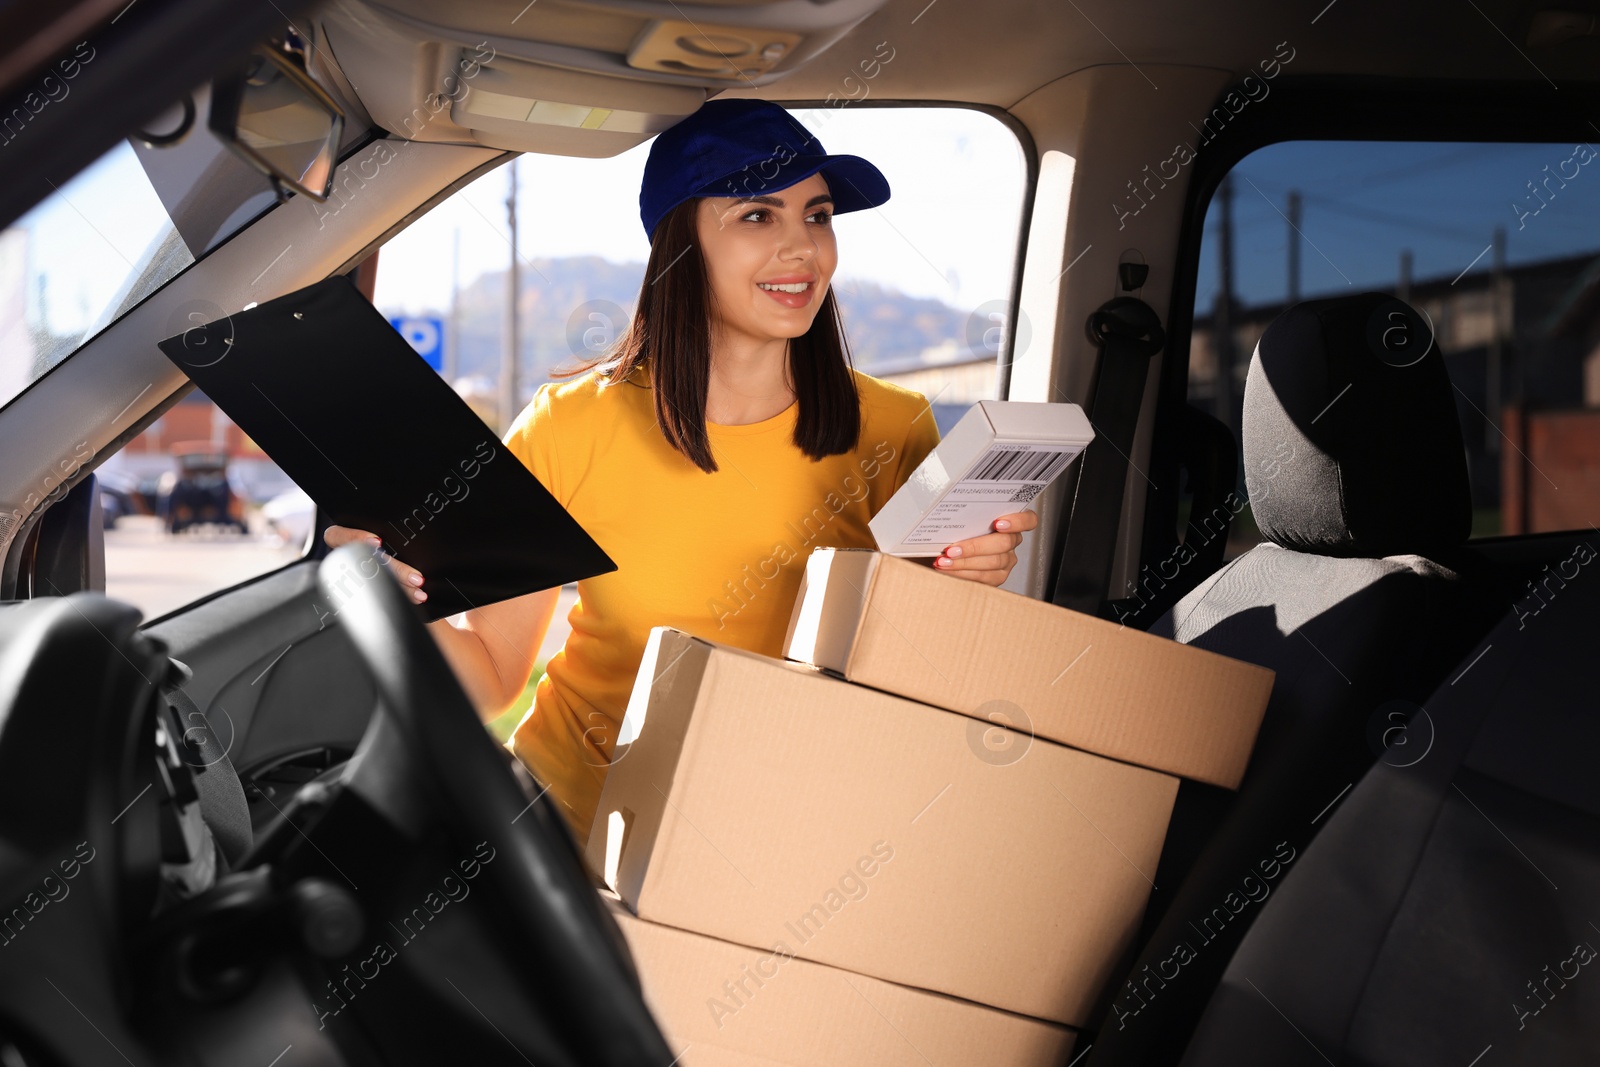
<box><xmin>323</xmin><ymin>0</ymin><xmax>885</xmax><ymax>158</ymax></box>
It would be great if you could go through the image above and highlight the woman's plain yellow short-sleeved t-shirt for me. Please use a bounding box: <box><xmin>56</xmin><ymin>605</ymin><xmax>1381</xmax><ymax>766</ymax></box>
<box><xmin>506</xmin><ymin>371</ymin><xmax>939</xmax><ymax>841</ymax></box>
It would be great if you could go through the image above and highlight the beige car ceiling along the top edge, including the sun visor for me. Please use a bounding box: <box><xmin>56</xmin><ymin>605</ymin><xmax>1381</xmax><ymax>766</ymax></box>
<box><xmin>318</xmin><ymin>0</ymin><xmax>1600</xmax><ymax>155</ymax></box>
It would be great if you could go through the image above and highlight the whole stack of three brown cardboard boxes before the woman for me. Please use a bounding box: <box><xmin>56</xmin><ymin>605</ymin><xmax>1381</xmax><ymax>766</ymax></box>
<box><xmin>587</xmin><ymin>550</ymin><xmax>1272</xmax><ymax>1067</ymax></box>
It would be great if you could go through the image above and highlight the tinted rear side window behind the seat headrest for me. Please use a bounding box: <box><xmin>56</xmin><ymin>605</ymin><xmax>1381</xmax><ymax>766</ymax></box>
<box><xmin>1179</xmin><ymin>141</ymin><xmax>1600</xmax><ymax>558</ymax></box>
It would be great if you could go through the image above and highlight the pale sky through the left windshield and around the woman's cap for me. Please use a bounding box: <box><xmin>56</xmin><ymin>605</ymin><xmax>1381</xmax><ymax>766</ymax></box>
<box><xmin>21</xmin><ymin>107</ymin><xmax>1026</xmax><ymax>355</ymax></box>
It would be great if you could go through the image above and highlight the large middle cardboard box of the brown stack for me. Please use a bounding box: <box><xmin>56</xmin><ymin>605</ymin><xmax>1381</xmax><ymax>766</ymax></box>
<box><xmin>587</xmin><ymin>630</ymin><xmax>1178</xmax><ymax>1025</ymax></box>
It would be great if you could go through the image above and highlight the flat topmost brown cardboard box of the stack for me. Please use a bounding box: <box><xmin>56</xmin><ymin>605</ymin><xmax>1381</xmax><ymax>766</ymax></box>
<box><xmin>784</xmin><ymin>549</ymin><xmax>1274</xmax><ymax>789</ymax></box>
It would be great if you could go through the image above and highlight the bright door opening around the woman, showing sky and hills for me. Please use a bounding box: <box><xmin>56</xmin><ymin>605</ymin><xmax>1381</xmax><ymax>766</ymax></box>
<box><xmin>374</xmin><ymin>103</ymin><xmax>1027</xmax><ymax>729</ymax></box>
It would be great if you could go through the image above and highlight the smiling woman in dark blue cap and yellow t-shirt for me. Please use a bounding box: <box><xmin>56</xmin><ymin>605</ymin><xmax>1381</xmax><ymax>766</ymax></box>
<box><xmin>325</xmin><ymin>101</ymin><xmax>1037</xmax><ymax>840</ymax></box>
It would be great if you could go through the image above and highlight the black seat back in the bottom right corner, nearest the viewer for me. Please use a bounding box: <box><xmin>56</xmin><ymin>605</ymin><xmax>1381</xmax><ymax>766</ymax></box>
<box><xmin>1182</xmin><ymin>559</ymin><xmax>1600</xmax><ymax>1067</ymax></box>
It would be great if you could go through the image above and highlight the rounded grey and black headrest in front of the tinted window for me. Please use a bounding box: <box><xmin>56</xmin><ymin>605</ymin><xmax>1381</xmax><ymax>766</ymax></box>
<box><xmin>1242</xmin><ymin>293</ymin><xmax>1472</xmax><ymax>558</ymax></box>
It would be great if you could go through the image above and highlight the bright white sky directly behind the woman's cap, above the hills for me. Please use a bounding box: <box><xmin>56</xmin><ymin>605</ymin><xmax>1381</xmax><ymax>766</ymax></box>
<box><xmin>376</xmin><ymin>107</ymin><xmax>1026</xmax><ymax>312</ymax></box>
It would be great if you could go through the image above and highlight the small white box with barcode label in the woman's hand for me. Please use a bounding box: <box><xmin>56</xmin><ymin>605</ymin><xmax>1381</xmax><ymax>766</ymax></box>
<box><xmin>867</xmin><ymin>400</ymin><xmax>1094</xmax><ymax>555</ymax></box>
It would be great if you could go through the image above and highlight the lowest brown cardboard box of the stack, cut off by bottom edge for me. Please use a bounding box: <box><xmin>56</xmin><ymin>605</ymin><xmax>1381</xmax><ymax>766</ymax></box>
<box><xmin>602</xmin><ymin>894</ymin><xmax>1077</xmax><ymax>1067</ymax></box>
